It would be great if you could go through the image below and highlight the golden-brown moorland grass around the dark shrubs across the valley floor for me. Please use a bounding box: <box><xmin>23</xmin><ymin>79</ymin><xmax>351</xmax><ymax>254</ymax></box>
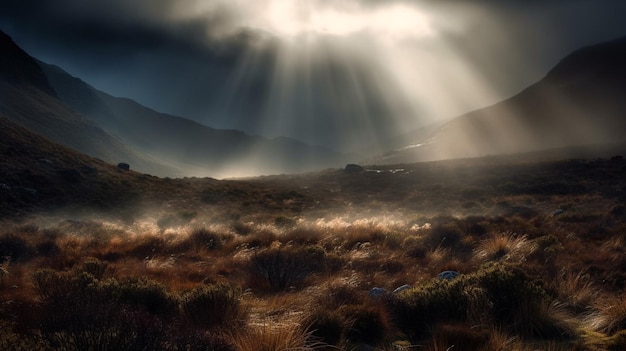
<box><xmin>0</xmin><ymin>155</ymin><xmax>626</xmax><ymax>351</ymax></box>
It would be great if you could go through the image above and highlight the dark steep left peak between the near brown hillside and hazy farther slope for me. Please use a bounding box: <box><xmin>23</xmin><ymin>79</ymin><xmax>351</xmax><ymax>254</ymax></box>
<box><xmin>0</xmin><ymin>32</ymin><xmax>174</xmax><ymax>174</ymax></box>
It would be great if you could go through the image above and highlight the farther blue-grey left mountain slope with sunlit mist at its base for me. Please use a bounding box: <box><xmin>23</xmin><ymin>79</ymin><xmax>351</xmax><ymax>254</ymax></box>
<box><xmin>40</xmin><ymin>62</ymin><xmax>347</xmax><ymax>177</ymax></box>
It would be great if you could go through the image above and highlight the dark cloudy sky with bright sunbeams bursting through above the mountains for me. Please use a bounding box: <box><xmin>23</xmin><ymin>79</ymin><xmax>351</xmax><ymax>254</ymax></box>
<box><xmin>0</xmin><ymin>0</ymin><xmax>626</xmax><ymax>151</ymax></box>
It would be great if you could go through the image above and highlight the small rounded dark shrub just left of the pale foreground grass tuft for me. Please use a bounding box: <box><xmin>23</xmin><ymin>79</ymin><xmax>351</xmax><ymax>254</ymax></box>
<box><xmin>180</xmin><ymin>284</ymin><xmax>245</xmax><ymax>327</ymax></box>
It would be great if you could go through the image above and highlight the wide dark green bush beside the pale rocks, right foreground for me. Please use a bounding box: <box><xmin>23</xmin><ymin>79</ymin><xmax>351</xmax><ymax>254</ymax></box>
<box><xmin>390</xmin><ymin>264</ymin><xmax>569</xmax><ymax>338</ymax></box>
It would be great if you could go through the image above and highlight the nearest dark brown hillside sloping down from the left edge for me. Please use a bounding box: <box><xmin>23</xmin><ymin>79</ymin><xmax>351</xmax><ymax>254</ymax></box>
<box><xmin>0</xmin><ymin>114</ymin><xmax>154</xmax><ymax>218</ymax></box>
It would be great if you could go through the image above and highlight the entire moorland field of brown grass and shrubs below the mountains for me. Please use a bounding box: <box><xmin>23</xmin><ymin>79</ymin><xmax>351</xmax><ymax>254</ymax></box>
<box><xmin>0</xmin><ymin>155</ymin><xmax>626</xmax><ymax>351</ymax></box>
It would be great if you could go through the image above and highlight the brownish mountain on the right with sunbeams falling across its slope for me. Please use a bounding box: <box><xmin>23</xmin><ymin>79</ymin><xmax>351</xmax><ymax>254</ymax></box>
<box><xmin>377</xmin><ymin>38</ymin><xmax>626</xmax><ymax>163</ymax></box>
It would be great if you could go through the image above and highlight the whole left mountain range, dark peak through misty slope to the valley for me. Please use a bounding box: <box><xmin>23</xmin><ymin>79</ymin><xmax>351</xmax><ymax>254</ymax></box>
<box><xmin>0</xmin><ymin>29</ymin><xmax>347</xmax><ymax>177</ymax></box>
